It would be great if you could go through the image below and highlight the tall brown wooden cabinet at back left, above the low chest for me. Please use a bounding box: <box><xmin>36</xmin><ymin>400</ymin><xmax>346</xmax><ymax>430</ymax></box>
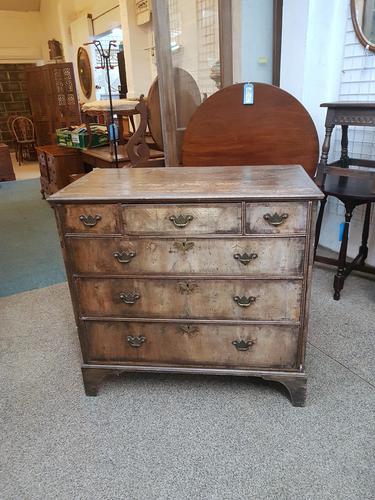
<box><xmin>26</xmin><ymin>63</ymin><xmax>81</xmax><ymax>146</ymax></box>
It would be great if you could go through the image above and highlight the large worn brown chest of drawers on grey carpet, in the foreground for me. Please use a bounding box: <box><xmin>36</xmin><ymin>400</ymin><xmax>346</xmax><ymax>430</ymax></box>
<box><xmin>49</xmin><ymin>165</ymin><xmax>322</xmax><ymax>405</ymax></box>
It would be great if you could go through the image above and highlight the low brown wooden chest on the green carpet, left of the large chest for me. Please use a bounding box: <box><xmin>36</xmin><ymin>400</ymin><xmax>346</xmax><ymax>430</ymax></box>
<box><xmin>36</xmin><ymin>145</ymin><xmax>85</xmax><ymax>198</ymax></box>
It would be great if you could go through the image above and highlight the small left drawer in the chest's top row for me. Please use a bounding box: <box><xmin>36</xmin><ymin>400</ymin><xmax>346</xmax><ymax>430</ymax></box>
<box><xmin>61</xmin><ymin>204</ymin><xmax>120</xmax><ymax>234</ymax></box>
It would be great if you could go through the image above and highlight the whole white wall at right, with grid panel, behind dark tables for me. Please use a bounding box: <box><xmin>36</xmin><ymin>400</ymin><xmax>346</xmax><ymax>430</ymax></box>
<box><xmin>280</xmin><ymin>0</ymin><xmax>375</xmax><ymax>265</ymax></box>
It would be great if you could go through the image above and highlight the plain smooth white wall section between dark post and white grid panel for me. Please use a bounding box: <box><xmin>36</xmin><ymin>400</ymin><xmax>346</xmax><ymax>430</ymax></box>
<box><xmin>280</xmin><ymin>0</ymin><xmax>347</xmax><ymax>143</ymax></box>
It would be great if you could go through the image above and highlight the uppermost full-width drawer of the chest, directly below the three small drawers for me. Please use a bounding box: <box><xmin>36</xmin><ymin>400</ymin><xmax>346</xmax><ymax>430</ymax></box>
<box><xmin>68</xmin><ymin>237</ymin><xmax>305</xmax><ymax>277</ymax></box>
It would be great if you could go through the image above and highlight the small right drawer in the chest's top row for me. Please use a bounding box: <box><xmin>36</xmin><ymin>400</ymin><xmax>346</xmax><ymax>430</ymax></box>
<box><xmin>246</xmin><ymin>202</ymin><xmax>307</xmax><ymax>234</ymax></box>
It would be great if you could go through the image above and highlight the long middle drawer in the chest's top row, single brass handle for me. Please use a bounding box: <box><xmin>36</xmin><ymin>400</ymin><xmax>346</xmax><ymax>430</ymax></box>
<box><xmin>122</xmin><ymin>203</ymin><xmax>241</xmax><ymax>235</ymax></box>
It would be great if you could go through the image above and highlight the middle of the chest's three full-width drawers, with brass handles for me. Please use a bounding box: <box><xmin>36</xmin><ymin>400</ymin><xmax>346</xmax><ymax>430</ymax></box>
<box><xmin>76</xmin><ymin>278</ymin><xmax>302</xmax><ymax>321</ymax></box>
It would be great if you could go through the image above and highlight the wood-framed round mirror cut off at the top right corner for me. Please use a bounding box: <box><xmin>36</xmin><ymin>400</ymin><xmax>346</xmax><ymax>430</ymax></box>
<box><xmin>350</xmin><ymin>0</ymin><xmax>375</xmax><ymax>52</ymax></box>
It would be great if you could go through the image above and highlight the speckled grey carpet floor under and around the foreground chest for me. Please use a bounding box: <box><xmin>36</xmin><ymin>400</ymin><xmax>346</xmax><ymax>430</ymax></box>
<box><xmin>0</xmin><ymin>269</ymin><xmax>375</xmax><ymax>500</ymax></box>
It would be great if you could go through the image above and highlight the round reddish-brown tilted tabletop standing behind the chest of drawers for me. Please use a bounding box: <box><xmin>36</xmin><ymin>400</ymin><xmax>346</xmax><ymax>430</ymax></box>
<box><xmin>182</xmin><ymin>83</ymin><xmax>319</xmax><ymax>177</ymax></box>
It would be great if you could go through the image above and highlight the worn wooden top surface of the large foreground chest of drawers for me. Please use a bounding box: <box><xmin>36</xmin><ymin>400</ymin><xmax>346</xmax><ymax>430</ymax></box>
<box><xmin>49</xmin><ymin>165</ymin><xmax>323</xmax><ymax>203</ymax></box>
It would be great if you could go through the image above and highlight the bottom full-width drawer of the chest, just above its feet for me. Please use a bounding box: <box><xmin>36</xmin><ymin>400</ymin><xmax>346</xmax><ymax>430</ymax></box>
<box><xmin>85</xmin><ymin>321</ymin><xmax>298</xmax><ymax>369</ymax></box>
